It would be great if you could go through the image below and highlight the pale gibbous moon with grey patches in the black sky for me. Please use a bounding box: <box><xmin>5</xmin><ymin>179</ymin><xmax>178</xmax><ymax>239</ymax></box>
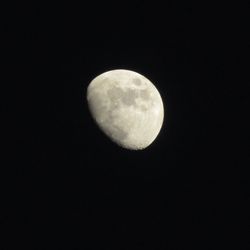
<box><xmin>87</xmin><ymin>69</ymin><xmax>164</xmax><ymax>150</ymax></box>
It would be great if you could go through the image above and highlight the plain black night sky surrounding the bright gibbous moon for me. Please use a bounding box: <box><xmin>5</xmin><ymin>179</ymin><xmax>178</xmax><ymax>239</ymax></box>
<box><xmin>0</xmin><ymin>1</ymin><xmax>249</xmax><ymax>249</ymax></box>
